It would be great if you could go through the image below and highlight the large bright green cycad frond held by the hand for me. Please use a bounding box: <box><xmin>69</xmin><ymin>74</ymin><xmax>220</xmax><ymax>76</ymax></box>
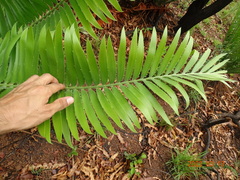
<box><xmin>0</xmin><ymin>0</ymin><xmax>232</xmax><ymax>147</ymax></box>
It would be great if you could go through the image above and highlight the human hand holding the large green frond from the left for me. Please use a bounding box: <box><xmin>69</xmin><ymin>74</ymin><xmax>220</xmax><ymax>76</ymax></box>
<box><xmin>0</xmin><ymin>74</ymin><xmax>74</xmax><ymax>134</ymax></box>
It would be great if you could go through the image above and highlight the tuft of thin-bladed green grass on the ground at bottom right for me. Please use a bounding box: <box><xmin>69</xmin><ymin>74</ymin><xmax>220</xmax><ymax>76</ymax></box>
<box><xmin>166</xmin><ymin>145</ymin><xmax>206</xmax><ymax>179</ymax></box>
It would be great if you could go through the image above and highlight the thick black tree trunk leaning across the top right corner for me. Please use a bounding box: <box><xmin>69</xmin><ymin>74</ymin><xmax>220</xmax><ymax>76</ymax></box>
<box><xmin>174</xmin><ymin>0</ymin><xmax>233</xmax><ymax>33</ymax></box>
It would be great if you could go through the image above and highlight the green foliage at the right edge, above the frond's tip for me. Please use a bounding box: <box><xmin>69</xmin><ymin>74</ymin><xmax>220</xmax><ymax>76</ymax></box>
<box><xmin>224</xmin><ymin>6</ymin><xmax>240</xmax><ymax>73</ymax></box>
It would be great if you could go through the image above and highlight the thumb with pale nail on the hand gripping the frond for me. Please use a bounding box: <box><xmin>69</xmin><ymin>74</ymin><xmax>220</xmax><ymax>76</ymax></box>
<box><xmin>45</xmin><ymin>96</ymin><xmax>74</xmax><ymax>117</ymax></box>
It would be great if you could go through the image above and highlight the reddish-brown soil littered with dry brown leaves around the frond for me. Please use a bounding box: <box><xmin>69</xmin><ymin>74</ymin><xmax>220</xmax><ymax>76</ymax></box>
<box><xmin>0</xmin><ymin>1</ymin><xmax>240</xmax><ymax>180</ymax></box>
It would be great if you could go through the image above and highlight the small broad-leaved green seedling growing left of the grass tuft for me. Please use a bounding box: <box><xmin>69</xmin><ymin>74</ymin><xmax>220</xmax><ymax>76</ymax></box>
<box><xmin>124</xmin><ymin>152</ymin><xmax>147</xmax><ymax>177</ymax></box>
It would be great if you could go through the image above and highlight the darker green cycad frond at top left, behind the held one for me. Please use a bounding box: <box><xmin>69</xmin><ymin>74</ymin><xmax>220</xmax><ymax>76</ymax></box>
<box><xmin>0</xmin><ymin>0</ymin><xmax>121</xmax><ymax>38</ymax></box>
